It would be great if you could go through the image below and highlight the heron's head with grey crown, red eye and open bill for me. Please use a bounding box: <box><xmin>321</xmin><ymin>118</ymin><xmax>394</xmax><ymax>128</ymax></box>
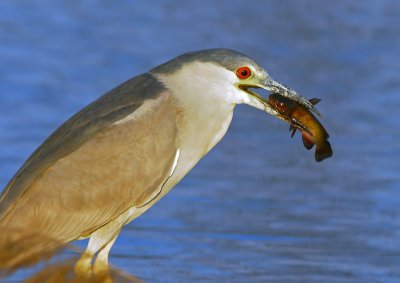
<box><xmin>150</xmin><ymin>49</ymin><xmax>318</xmax><ymax>119</ymax></box>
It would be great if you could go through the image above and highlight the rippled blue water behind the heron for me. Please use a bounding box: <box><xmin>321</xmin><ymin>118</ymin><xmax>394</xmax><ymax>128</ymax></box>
<box><xmin>0</xmin><ymin>0</ymin><xmax>400</xmax><ymax>283</ymax></box>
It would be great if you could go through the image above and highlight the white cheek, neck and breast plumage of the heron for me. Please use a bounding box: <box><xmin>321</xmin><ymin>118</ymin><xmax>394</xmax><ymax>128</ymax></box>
<box><xmin>156</xmin><ymin>62</ymin><xmax>243</xmax><ymax>181</ymax></box>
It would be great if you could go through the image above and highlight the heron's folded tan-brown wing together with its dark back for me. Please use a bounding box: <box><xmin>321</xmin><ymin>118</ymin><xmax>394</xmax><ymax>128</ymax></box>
<box><xmin>0</xmin><ymin>71</ymin><xmax>176</xmax><ymax>242</ymax></box>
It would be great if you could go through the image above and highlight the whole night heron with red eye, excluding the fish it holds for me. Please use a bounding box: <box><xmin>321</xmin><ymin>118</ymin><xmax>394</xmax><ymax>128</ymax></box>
<box><xmin>0</xmin><ymin>49</ymin><xmax>315</xmax><ymax>278</ymax></box>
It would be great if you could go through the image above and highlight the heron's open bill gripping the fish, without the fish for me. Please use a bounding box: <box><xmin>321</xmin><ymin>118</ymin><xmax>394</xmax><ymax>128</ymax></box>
<box><xmin>239</xmin><ymin>78</ymin><xmax>319</xmax><ymax>122</ymax></box>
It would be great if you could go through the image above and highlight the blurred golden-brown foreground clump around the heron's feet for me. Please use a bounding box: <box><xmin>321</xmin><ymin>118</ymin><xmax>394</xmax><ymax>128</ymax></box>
<box><xmin>0</xmin><ymin>230</ymin><xmax>143</xmax><ymax>283</ymax></box>
